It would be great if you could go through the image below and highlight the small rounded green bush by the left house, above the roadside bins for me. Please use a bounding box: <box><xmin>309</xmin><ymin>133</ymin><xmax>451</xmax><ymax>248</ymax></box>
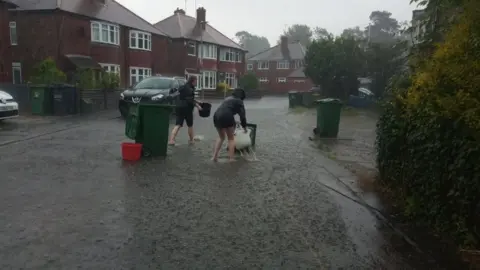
<box><xmin>29</xmin><ymin>57</ymin><xmax>67</xmax><ymax>84</ymax></box>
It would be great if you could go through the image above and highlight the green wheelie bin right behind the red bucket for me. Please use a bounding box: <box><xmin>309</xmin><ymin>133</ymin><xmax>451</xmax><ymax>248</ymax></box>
<box><xmin>135</xmin><ymin>104</ymin><xmax>174</xmax><ymax>156</ymax></box>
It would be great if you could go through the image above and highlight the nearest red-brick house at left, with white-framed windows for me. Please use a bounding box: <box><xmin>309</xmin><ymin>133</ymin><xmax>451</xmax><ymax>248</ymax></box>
<box><xmin>0</xmin><ymin>0</ymin><xmax>168</xmax><ymax>86</ymax></box>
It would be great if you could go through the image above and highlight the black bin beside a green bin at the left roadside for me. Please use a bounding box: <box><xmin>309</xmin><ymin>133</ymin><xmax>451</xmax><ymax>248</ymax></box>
<box><xmin>51</xmin><ymin>84</ymin><xmax>78</xmax><ymax>115</ymax></box>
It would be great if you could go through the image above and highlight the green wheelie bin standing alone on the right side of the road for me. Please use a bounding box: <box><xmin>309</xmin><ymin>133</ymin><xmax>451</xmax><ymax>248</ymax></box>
<box><xmin>314</xmin><ymin>98</ymin><xmax>343</xmax><ymax>138</ymax></box>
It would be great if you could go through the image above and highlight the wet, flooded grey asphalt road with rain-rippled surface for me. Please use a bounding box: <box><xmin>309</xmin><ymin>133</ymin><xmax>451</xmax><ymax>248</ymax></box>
<box><xmin>0</xmin><ymin>98</ymin><xmax>424</xmax><ymax>269</ymax></box>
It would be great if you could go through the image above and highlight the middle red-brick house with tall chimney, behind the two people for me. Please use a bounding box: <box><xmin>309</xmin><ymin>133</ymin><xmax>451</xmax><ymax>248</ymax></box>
<box><xmin>154</xmin><ymin>8</ymin><xmax>246</xmax><ymax>89</ymax></box>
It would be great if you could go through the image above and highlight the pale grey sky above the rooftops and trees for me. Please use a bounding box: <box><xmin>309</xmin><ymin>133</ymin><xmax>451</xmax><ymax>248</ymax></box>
<box><xmin>117</xmin><ymin>0</ymin><xmax>414</xmax><ymax>45</ymax></box>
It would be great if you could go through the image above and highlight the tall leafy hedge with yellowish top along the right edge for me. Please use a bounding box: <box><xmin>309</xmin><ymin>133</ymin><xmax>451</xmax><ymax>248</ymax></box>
<box><xmin>376</xmin><ymin>1</ymin><xmax>480</xmax><ymax>246</ymax></box>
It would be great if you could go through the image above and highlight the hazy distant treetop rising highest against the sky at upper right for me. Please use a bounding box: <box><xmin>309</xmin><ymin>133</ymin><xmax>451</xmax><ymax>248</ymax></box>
<box><xmin>365</xmin><ymin>10</ymin><xmax>400</xmax><ymax>43</ymax></box>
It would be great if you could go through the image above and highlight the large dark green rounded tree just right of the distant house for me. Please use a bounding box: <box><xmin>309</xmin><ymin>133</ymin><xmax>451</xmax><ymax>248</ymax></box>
<box><xmin>304</xmin><ymin>37</ymin><xmax>364</xmax><ymax>99</ymax></box>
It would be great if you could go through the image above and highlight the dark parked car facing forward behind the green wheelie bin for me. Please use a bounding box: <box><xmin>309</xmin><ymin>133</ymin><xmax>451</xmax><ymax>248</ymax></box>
<box><xmin>118</xmin><ymin>76</ymin><xmax>185</xmax><ymax>118</ymax></box>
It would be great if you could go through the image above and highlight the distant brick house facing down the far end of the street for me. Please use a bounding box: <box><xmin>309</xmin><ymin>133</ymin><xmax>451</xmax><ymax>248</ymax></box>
<box><xmin>247</xmin><ymin>37</ymin><xmax>313</xmax><ymax>93</ymax></box>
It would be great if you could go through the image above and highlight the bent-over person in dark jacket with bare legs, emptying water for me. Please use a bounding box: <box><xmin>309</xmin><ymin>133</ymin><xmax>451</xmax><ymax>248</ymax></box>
<box><xmin>212</xmin><ymin>88</ymin><xmax>247</xmax><ymax>162</ymax></box>
